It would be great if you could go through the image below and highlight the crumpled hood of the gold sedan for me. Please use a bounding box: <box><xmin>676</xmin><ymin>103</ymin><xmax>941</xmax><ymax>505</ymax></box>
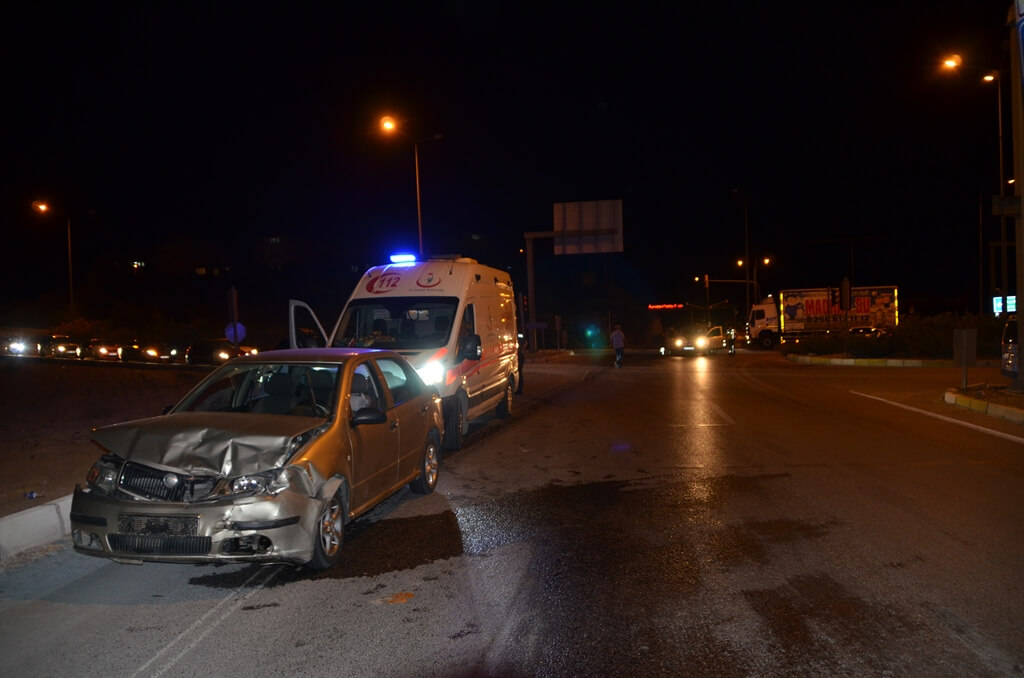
<box><xmin>92</xmin><ymin>412</ymin><xmax>323</xmax><ymax>476</ymax></box>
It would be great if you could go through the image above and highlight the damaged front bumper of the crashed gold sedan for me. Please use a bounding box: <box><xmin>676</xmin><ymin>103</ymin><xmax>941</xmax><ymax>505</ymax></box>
<box><xmin>71</xmin><ymin>485</ymin><xmax>322</xmax><ymax>564</ymax></box>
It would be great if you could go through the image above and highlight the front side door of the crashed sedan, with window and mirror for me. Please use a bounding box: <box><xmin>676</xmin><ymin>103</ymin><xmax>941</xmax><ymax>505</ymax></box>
<box><xmin>344</xmin><ymin>359</ymin><xmax>399</xmax><ymax>513</ymax></box>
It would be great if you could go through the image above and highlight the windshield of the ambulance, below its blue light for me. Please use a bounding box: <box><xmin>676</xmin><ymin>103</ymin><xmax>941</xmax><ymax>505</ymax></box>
<box><xmin>334</xmin><ymin>297</ymin><xmax>459</xmax><ymax>350</ymax></box>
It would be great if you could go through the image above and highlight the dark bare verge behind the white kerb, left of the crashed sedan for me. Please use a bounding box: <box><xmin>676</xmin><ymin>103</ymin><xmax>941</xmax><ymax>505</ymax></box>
<box><xmin>0</xmin><ymin>357</ymin><xmax>204</xmax><ymax>516</ymax></box>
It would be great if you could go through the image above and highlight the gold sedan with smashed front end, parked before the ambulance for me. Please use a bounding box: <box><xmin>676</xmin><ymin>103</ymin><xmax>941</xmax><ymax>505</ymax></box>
<box><xmin>71</xmin><ymin>348</ymin><xmax>443</xmax><ymax>569</ymax></box>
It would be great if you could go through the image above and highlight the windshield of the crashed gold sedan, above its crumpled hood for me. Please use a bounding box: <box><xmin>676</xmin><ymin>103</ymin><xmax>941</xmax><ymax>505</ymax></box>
<box><xmin>172</xmin><ymin>363</ymin><xmax>341</xmax><ymax>418</ymax></box>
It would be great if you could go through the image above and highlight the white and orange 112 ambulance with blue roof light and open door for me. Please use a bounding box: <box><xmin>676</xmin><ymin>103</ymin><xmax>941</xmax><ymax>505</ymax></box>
<box><xmin>289</xmin><ymin>256</ymin><xmax>519</xmax><ymax>450</ymax></box>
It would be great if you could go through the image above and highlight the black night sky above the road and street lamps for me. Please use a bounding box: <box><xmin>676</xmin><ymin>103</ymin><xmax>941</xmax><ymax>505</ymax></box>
<box><xmin>0</xmin><ymin>0</ymin><xmax>1012</xmax><ymax>335</ymax></box>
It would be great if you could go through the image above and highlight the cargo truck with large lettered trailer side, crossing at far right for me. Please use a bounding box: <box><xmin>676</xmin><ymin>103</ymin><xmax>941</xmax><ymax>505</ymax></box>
<box><xmin>746</xmin><ymin>285</ymin><xmax>899</xmax><ymax>348</ymax></box>
